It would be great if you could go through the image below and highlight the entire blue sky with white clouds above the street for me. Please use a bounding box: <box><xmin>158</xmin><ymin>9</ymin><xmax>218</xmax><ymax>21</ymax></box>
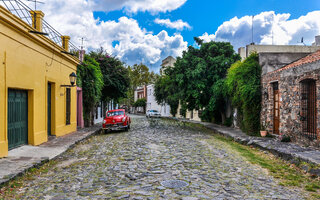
<box><xmin>24</xmin><ymin>0</ymin><xmax>320</xmax><ymax>72</ymax></box>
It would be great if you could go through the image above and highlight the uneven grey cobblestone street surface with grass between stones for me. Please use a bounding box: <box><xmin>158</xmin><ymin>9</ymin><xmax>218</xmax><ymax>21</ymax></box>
<box><xmin>13</xmin><ymin>117</ymin><xmax>304</xmax><ymax>200</ymax></box>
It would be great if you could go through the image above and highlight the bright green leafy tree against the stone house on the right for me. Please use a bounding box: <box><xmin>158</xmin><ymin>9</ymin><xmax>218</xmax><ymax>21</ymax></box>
<box><xmin>226</xmin><ymin>53</ymin><xmax>261</xmax><ymax>135</ymax></box>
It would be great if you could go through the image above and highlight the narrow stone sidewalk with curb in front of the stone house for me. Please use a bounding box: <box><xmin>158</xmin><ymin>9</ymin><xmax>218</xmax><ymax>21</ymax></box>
<box><xmin>170</xmin><ymin>118</ymin><xmax>320</xmax><ymax>176</ymax></box>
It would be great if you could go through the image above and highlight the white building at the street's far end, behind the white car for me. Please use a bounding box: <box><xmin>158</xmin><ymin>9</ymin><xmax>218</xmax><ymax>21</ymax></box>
<box><xmin>147</xmin><ymin>84</ymin><xmax>171</xmax><ymax>117</ymax></box>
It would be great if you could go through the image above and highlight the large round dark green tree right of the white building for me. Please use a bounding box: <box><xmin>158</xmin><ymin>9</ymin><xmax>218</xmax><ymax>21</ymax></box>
<box><xmin>165</xmin><ymin>38</ymin><xmax>240</xmax><ymax>122</ymax></box>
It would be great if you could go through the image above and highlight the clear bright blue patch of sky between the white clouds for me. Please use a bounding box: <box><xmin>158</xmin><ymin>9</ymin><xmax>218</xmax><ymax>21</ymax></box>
<box><xmin>94</xmin><ymin>0</ymin><xmax>320</xmax><ymax>45</ymax></box>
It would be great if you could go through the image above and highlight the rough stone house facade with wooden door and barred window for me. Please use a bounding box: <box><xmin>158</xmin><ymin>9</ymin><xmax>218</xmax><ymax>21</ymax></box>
<box><xmin>261</xmin><ymin>50</ymin><xmax>320</xmax><ymax>147</ymax></box>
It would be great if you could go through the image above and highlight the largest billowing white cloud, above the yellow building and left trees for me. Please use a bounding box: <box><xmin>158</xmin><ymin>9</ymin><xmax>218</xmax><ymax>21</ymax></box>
<box><xmin>20</xmin><ymin>0</ymin><xmax>187</xmax><ymax>71</ymax></box>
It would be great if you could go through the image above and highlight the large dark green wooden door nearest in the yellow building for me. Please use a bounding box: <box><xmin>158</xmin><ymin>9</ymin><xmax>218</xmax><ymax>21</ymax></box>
<box><xmin>8</xmin><ymin>90</ymin><xmax>28</xmax><ymax>149</ymax></box>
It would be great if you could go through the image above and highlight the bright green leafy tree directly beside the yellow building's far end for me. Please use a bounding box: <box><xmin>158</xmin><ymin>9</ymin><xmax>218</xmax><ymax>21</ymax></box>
<box><xmin>77</xmin><ymin>55</ymin><xmax>103</xmax><ymax>127</ymax></box>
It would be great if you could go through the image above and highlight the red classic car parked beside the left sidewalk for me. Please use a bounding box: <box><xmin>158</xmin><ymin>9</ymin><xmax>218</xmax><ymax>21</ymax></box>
<box><xmin>102</xmin><ymin>109</ymin><xmax>131</xmax><ymax>132</ymax></box>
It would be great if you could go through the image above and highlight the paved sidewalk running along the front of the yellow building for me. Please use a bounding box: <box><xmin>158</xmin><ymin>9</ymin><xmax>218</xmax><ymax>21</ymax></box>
<box><xmin>0</xmin><ymin>124</ymin><xmax>101</xmax><ymax>187</ymax></box>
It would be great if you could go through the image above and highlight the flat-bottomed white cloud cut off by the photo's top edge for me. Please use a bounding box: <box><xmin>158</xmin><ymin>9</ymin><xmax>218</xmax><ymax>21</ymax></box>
<box><xmin>91</xmin><ymin>0</ymin><xmax>187</xmax><ymax>14</ymax></box>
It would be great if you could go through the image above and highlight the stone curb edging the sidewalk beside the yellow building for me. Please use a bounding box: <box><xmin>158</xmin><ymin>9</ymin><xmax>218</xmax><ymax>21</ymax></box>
<box><xmin>0</xmin><ymin>127</ymin><xmax>101</xmax><ymax>188</ymax></box>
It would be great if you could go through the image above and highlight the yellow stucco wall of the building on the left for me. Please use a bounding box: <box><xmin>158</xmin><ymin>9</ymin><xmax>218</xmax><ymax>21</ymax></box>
<box><xmin>0</xmin><ymin>6</ymin><xmax>79</xmax><ymax>157</ymax></box>
